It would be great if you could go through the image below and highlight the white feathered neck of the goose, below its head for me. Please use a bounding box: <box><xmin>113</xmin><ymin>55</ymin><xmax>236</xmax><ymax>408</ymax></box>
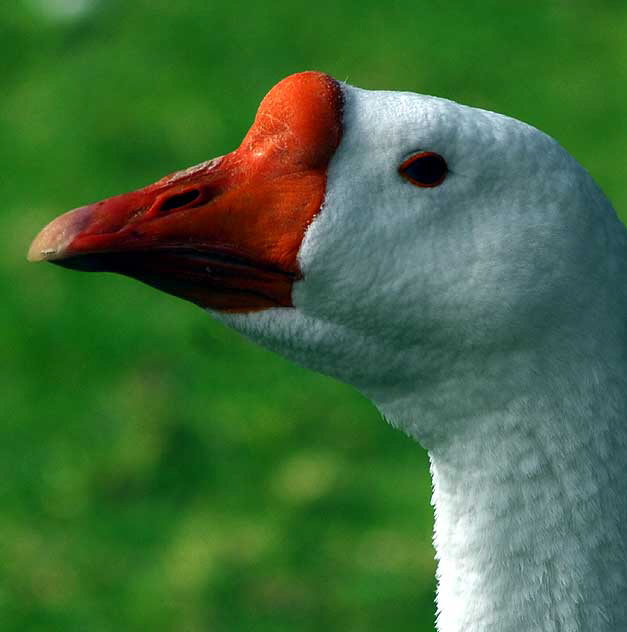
<box><xmin>372</xmin><ymin>325</ymin><xmax>627</xmax><ymax>632</ymax></box>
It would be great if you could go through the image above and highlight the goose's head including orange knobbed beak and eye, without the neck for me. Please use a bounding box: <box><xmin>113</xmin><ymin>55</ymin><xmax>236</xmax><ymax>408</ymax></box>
<box><xmin>29</xmin><ymin>72</ymin><xmax>625</xmax><ymax>443</ymax></box>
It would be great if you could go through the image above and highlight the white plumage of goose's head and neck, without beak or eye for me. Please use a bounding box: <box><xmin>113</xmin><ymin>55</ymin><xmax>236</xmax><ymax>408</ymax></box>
<box><xmin>216</xmin><ymin>81</ymin><xmax>627</xmax><ymax>632</ymax></box>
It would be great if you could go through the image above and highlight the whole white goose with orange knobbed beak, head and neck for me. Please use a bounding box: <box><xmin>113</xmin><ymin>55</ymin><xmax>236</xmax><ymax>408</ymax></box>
<box><xmin>28</xmin><ymin>71</ymin><xmax>627</xmax><ymax>632</ymax></box>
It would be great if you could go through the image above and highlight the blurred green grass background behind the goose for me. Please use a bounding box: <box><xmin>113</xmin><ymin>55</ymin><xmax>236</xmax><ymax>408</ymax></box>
<box><xmin>0</xmin><ymin>0</ymin><xmax>627</xmax><ymax>632</ymax></box>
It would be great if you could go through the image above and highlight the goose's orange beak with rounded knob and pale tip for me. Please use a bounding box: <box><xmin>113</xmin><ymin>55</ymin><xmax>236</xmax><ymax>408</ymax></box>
<box><xmin>28</xmin><ymin>72</ymin><xmax>342</xmax><ymax>312</ymax></box>
